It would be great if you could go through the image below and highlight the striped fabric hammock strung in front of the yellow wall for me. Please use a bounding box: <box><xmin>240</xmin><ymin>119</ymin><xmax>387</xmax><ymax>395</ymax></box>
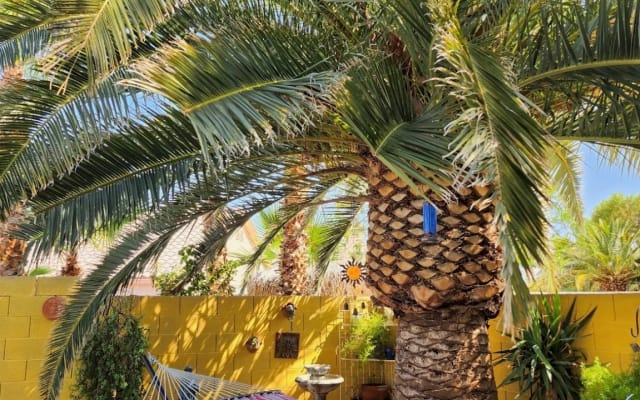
<box><xmin>143</xmin><ymin>354</ymin><xmax>295</xmax><ymax>400</ymax></box>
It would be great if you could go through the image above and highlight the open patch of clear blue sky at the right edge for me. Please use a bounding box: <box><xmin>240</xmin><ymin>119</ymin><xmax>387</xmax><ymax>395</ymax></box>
<box><xmin>581</xmin><ymin>146</ymin><xmax>640</xmax><ymax>217</ymax></box>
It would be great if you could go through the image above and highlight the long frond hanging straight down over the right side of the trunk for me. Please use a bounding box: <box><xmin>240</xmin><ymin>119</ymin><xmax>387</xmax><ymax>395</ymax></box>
<box><xmin>432</xmin><ymin>2</ymin><xmax>548</xmax><ymax>324</ymax></box>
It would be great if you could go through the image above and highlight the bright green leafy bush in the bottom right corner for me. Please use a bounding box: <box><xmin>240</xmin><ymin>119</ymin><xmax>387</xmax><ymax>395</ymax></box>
<box><xmin>580</xmin><ymin>357</ymin><xmax>640</xmax><ymax>400</ymax></box>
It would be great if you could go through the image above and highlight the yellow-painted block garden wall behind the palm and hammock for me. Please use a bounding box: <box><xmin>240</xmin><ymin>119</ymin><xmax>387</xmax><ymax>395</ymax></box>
<box><xmin>0</xmin><ymin>277</ymin><xmax>640</xmax><ymax>400</ymax></box>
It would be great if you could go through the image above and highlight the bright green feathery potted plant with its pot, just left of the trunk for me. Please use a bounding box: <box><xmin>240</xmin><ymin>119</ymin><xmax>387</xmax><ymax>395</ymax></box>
<box><xmin>342</xmin><ymin>311</ymin><xmax>395</xmax><ymax>400</ymax></box>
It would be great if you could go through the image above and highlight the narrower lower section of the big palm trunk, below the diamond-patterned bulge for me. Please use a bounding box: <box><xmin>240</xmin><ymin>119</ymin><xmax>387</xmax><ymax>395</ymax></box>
<box><xmin>393</xmin><ymin>307</ymin><xmax>497</xmax><ymax>400</ymax></box>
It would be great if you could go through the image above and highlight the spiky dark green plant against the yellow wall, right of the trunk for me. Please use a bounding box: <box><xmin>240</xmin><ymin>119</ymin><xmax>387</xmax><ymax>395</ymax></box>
<box><xmin>497</xmin><ymin>295</ymin><xmax>596</xmax><ymax>400</ymax></box>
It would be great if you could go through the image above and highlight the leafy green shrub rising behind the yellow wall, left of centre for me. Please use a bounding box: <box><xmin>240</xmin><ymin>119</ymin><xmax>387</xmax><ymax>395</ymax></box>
<box><xmin>154</xmin><ymin>246</ymin><xmax>240</xmax><ymax>296</ymax></box>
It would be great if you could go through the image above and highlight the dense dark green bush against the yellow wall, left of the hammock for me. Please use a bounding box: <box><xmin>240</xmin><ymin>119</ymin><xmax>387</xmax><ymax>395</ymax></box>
<box><xmin>73</xmin><ymin>310</ymin><xmax>147</xmax><ymax>400</ymax></box>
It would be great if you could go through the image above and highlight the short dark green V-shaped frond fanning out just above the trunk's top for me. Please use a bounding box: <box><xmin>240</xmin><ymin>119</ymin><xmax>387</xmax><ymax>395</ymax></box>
<box><xmin>341</xmin><ymin>59</ymin><xmax>451</xmax><ymax>193</ymax></box>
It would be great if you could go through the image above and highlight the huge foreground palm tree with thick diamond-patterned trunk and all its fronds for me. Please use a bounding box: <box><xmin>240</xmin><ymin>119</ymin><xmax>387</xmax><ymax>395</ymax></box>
<box><xmin>0</xmin><ymin>0</ymin><xmax>640</xmax><ymax>399</ymax></box>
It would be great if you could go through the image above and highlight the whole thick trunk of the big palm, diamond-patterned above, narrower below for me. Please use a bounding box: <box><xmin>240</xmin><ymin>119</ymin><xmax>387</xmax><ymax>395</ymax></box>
<box><xmin>367</xmin><ymin>157</ymin><xmax>503</xmax><ymax>400</ymax></box>
